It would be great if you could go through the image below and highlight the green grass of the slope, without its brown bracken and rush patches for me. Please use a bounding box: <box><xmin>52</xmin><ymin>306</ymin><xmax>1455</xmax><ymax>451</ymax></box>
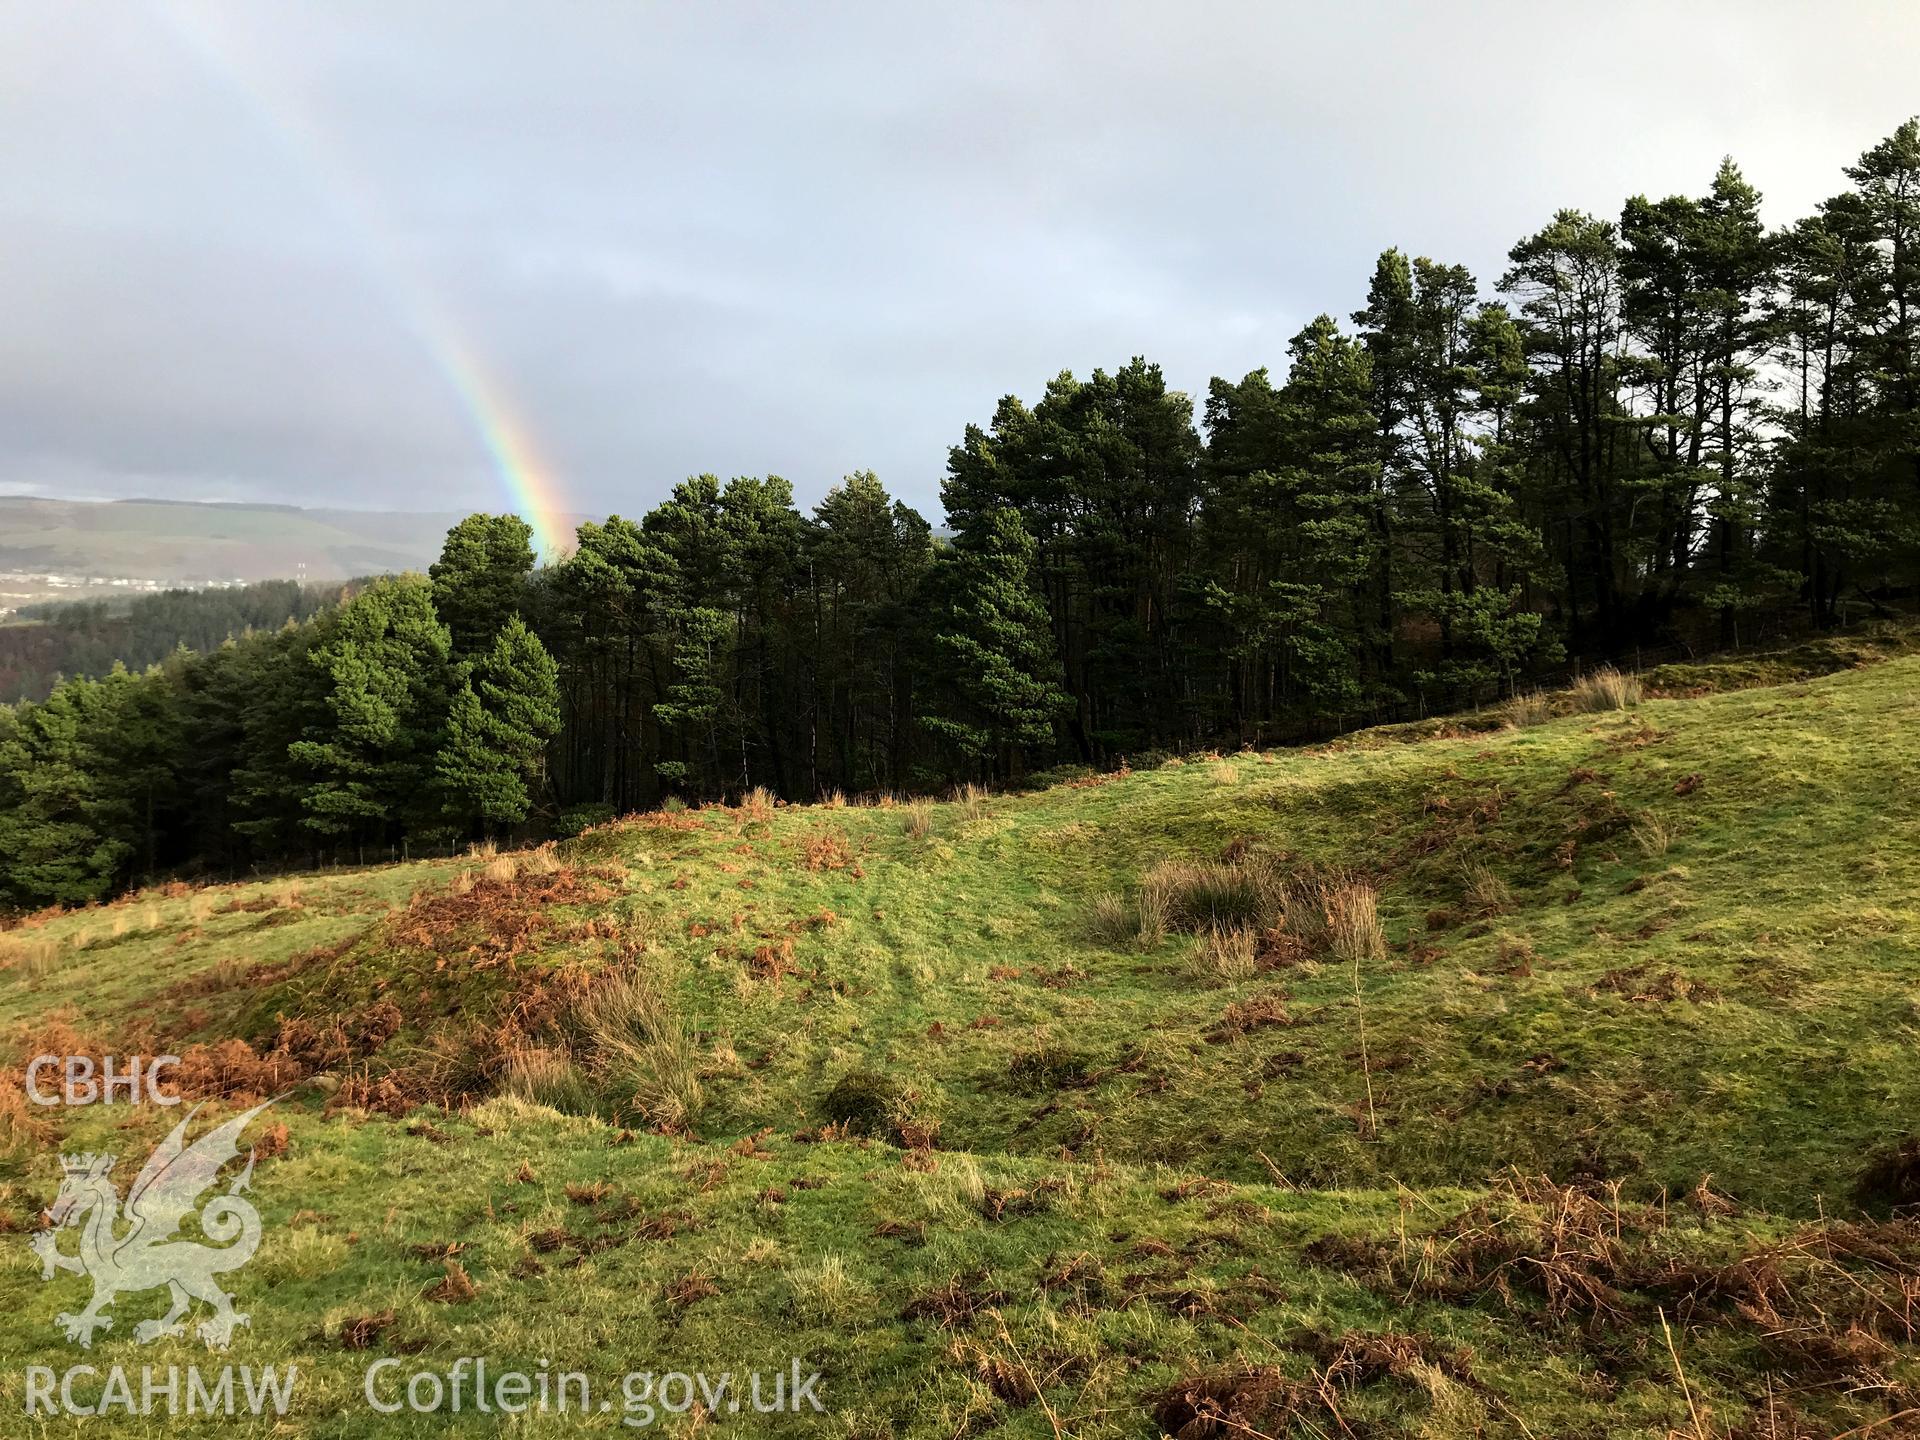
<box><xmin>0</xmin><ymin>660</ymin><xmax>1920</xmax><ymax>1436</ymax></box>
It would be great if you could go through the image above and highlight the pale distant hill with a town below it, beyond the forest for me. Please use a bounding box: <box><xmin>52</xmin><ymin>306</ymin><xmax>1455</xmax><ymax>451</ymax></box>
<box><xmin>0</xmin><ymin>495</ymin><xmax>461</xmax><ymax>586</ymax></box>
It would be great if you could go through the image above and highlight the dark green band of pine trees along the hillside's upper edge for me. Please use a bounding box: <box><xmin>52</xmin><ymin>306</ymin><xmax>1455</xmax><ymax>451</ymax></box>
<box><xmin>0</xmin><ymin>123</ymin><xmax>1920</xmax><ymax>904</ymax></box>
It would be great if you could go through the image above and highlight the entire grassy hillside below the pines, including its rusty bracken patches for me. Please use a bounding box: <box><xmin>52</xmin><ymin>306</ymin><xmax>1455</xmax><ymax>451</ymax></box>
<box><xmin>0</xmin><ymin>659</ymin><xmax>1920</xmax><ymax>1440</ymax></box>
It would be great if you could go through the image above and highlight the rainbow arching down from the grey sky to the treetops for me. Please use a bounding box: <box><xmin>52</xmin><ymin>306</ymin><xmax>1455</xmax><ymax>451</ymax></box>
<box><xmin>152</xmin><ymin>0</ymin><xmax>572</xmax><ymax>561</ymax></box>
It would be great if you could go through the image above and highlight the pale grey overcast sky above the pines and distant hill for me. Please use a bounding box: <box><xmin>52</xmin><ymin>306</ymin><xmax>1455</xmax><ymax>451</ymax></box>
<box><xmin>0</xmin><ymin>0</ymin><xmax>1920</xmax><ymax>515</ymax></box>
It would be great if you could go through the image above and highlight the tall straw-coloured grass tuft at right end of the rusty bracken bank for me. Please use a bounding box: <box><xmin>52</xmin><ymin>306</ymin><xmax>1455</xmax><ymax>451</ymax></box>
<box><xmin>582</xmin><ymin>970</ymin><xmax>705</xmax><ymax>1135</ymax></box>
